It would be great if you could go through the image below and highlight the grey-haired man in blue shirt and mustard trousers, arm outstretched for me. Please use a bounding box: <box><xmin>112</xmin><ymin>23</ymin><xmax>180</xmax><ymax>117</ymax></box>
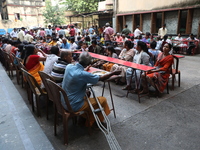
<box><xmin>61</xmin><ymin>52</ymin><xmax>120</xmax><ymax>126</ymax></box>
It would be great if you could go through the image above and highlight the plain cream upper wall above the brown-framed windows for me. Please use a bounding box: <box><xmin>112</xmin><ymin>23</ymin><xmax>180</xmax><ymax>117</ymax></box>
<box><xmin>117</xmin><ymin>0</ymin><xmax>199</xmax><ymax>14</ymax></box>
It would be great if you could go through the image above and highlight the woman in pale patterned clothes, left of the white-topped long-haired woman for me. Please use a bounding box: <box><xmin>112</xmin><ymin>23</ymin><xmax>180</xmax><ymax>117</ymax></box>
<box><xmin>110</xmin><ymin>41</ymin><xmax>135</xmax><ymax>83</ymax></box>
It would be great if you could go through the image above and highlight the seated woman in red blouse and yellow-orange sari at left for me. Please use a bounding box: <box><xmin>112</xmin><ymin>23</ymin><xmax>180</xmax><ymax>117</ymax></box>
<box><xmin>24</xmin><ymin>44</ymin><xmax>46</xmax><ymax>85</ymax></box>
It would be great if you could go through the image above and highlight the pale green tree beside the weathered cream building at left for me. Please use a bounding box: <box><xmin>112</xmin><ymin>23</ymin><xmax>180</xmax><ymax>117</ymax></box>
<box><xmin>43</xmin><ymin>1</ymin><xmax>65</xmax><ymax>25</ymax></box>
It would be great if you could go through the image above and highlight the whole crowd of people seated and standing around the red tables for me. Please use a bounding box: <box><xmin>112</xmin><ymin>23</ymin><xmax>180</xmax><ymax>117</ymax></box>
<box><xmin>1</xmin><ymin>23</ymin><xmax>197</xmax><ymax>125</ymax></box>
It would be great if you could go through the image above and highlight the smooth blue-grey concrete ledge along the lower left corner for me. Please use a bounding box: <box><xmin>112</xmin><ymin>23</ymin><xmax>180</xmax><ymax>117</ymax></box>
<box><xmin>0</xmin><ymin>65</ymin><xmax>54</xmax><ymax>150</ymax></box>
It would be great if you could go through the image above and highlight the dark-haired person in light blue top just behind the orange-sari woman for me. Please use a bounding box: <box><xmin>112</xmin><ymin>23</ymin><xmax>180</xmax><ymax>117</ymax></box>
<box><xmin>148</xmin><ymin>41</ymin><xmax>161</xmax><ymax>66</ymax></box>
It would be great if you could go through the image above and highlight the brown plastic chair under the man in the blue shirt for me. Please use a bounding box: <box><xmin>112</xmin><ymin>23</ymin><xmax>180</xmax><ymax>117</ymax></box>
<box><xmin>47</xmin><ymin>79</ymin><xmax>89</xmax><ymax>145</ymax></box>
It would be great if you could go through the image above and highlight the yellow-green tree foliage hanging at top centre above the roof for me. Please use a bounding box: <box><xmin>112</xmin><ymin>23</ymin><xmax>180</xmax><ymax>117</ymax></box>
<box><xmin>63</xmin><ymin>0</ymin><xmax>99</xmax><ymax>14</ymax></box>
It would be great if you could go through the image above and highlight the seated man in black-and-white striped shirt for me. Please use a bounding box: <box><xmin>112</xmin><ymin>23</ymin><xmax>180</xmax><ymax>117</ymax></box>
<box><xmin>51</xmin><ymin>51</ymin><xmax>72</xmax><ymax>85</ymax></box>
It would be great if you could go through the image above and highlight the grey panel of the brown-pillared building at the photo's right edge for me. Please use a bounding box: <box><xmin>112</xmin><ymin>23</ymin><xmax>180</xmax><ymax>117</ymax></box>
<box><xmin>192</xmin><ymin>9</ymin><xmax>200</xmax><ymax>35</ymax></box>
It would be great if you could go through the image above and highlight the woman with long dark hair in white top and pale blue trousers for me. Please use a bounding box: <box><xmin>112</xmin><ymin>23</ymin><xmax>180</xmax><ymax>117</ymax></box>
<box><xmin>123</xmin><ymin>41</ymin><xmax>151</xmax><ymax>90</ymax></box>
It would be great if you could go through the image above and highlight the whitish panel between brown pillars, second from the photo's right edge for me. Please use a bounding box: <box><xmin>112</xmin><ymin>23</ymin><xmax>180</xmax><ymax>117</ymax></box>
<box><xmin>165</xmin><ymin>11</ymin><xmax>178</xmax><ymax>34</ymax></box>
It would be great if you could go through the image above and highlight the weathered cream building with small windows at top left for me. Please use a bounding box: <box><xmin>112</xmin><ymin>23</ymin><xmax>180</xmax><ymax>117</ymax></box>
<box><xmin>0</xmin><ymin>0</ymin><xmax>45</xmax><ymax>29</ymax></box>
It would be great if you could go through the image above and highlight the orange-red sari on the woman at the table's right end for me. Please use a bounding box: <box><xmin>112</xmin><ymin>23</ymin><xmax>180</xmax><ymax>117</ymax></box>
<box><xmin>147</xmin><ymin>53</ymin><xmax>174</xmax><ymax>93</ymax></box>
